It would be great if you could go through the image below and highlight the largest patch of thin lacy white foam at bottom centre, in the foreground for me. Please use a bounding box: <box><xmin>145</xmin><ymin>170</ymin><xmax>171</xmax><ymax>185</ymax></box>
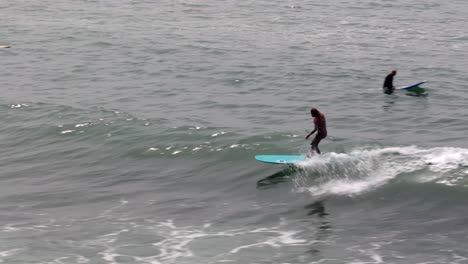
<box><xmin>103</xmin><ymin>220</ymin><xmax>310</xmax><ymax>264</ymax></box>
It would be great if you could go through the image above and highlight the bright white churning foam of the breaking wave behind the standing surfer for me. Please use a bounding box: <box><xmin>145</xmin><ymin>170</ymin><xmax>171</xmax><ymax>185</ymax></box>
<box><xmin>296</xmin><ymin>146</ymin><xmax>468</xmax><ymax>196</ymax></box>
